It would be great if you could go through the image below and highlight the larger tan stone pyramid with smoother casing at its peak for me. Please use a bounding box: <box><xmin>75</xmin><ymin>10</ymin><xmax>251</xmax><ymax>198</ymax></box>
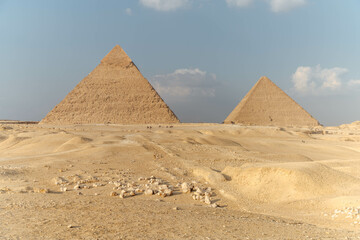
<box><xmin>40</xmin><ymin>45</ymin><xmax>179</xmax><ymax>124</ymax></box>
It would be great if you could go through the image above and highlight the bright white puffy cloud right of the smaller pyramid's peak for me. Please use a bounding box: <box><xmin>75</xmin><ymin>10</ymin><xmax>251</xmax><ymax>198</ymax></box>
<box><xmin>292</xmin><ymin>65</ymin><xmax>348</xmax><ymax>94</ymax></box>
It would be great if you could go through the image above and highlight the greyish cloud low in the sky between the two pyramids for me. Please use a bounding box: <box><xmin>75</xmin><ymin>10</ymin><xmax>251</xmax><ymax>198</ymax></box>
<box><xmin>151</xmin><ymin>68</ymin><xmax>219</xmax><ymax>97</ymax></box>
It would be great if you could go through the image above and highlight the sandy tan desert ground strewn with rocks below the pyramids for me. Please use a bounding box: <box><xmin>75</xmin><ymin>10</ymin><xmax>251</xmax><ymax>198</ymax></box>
<box><xmin>0</xmin><ymin>123</ymin><xmax>360</xmax><ymax>239</ymax></box>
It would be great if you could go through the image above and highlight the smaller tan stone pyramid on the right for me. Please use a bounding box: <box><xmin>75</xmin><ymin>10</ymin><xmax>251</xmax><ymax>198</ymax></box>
<box><xmin>224</xmin><ymin>77</ymin><xmax>319</xmax><ymax>126</ymax></box>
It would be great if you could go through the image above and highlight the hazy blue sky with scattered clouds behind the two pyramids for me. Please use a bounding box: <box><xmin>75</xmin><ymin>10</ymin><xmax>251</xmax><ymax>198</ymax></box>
<box><xmin>0</xmin><ymin>0</ymin><xmax>360</xmax><ymax>125</ymax></box>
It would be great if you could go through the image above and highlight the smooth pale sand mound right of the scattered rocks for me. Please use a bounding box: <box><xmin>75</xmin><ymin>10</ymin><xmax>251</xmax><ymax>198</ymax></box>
<box><xmin>222</xmin><ymin>162</ymin><xmax>360</xmax><ymax>203</ymax></box>
